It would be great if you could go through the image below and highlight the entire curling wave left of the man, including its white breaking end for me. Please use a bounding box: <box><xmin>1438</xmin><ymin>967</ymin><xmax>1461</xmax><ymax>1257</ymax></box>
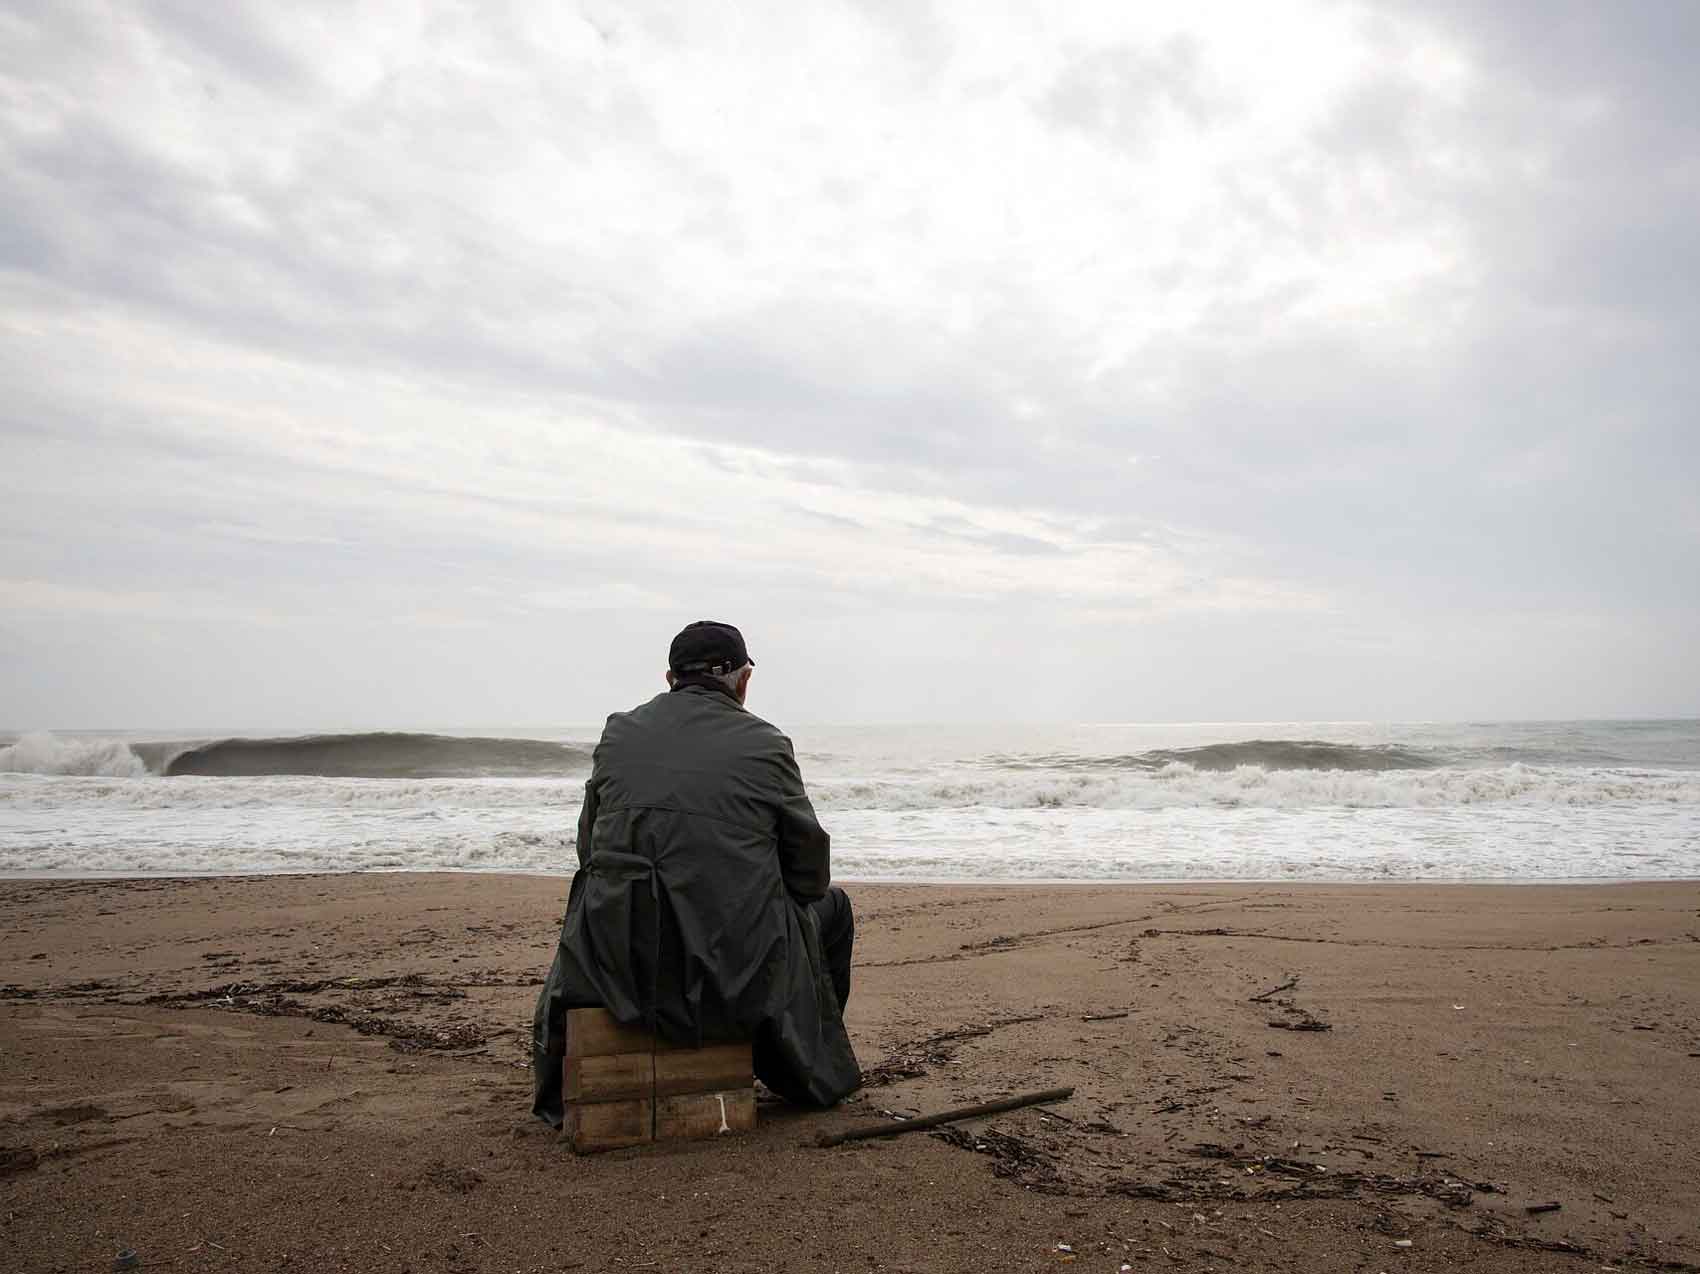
<box><xmin>0</xmin><ymin>731</ymin><xmax>590</xmax><ymax>779</ymax></box>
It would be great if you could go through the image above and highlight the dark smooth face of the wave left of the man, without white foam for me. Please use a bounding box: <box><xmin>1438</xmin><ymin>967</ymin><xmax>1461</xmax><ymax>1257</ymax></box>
<box><xmin>163</xmin><ymin>731</ymin><xmax>590</xmax><ymax>779</ymax></box>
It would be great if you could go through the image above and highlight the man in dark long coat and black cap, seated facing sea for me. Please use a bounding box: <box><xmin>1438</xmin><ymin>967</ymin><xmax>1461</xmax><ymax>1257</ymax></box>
<box><xmin>532</xmin><ymin>619</ymin><xmax>862</xmax><ymax>1124</ymax></box>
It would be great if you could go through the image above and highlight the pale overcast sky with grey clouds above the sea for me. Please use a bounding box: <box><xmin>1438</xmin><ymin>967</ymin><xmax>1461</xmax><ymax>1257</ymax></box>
<box><xmin>0</xmin><ymin>0</ymin><xmax>1700</xmax><ymax>728</ymax></box>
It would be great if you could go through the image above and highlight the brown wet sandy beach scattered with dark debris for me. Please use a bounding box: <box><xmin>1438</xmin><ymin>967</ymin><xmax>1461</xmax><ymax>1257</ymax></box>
<box><xmin>0</xmin><ymin>874</ymin><xmax>1700</xmax><ymax>1272</ymax></box>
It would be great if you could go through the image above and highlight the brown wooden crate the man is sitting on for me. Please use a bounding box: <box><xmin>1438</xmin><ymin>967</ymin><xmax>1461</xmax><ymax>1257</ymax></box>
<box><xmin>561</xmin><ymin>1009</ymin><xmax>755</xmax><ymax>1155</ymax></box>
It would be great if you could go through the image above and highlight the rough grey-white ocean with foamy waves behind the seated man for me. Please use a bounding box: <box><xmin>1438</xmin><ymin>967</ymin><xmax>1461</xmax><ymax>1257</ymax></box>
<box><xmin>0</xmin><ymin>719</ymin><xmax>1700</xmax><ymax>881</ymax></box>
